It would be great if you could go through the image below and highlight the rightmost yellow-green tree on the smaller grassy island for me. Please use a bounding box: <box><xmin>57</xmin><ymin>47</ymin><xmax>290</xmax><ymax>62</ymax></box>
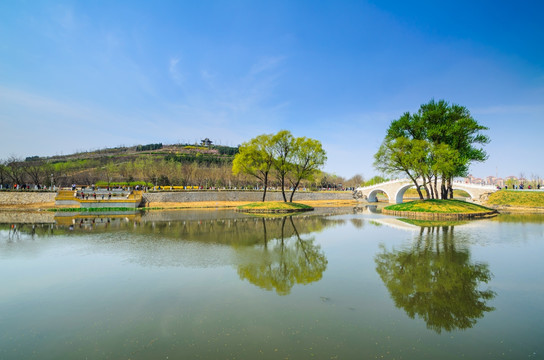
<box><xmin>289</xmin><ymin>137</ymin><xmax>327</xmax><ymax>202</ymax></box>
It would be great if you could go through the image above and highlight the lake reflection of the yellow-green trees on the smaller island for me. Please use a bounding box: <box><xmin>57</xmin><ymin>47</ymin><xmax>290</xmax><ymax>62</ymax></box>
<box><xmin>238</xmin><ymin>216</ymin><xmax>327</xmax><ymax>295</ymax></box>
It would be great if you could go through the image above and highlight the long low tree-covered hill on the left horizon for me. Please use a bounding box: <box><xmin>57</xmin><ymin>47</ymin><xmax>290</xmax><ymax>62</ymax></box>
<box><xmin>0</xmin><ymin>143</ymin><xmax>240</xmax><ymax>188</ymax></box>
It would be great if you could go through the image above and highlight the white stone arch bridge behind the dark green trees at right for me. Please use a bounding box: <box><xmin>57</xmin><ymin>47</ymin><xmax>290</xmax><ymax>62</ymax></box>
<box><xmin>353</xmin><ymin>179</ymin><xmax>497</xmax><ymax>204</ymax></box>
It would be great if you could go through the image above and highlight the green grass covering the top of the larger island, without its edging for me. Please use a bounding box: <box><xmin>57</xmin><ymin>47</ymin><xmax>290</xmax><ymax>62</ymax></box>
<box><xmin>385</xmin><ymin>199</ymin><xmax>493</xmax><ymax>214</ymax></box>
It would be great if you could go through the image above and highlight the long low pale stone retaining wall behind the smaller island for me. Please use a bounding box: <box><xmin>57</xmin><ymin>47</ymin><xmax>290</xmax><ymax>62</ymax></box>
<box><xmin>143</xmin><ymin>190</ymin><xmax>353</xmax><ymax>203</ymax></box>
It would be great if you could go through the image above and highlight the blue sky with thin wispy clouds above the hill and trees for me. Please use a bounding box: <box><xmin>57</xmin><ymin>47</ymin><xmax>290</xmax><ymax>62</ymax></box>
<box><xmin>0</xmin><ymin>0</ymin><xmax>544</xmax><ymax>178</ymax></box>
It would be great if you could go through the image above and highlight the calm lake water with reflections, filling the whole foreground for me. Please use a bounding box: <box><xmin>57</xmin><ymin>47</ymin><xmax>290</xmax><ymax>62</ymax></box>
<box><xmin>0</xmin><ymin>209</ymin><xmax>544</xmax><ymax>359</ymax></box>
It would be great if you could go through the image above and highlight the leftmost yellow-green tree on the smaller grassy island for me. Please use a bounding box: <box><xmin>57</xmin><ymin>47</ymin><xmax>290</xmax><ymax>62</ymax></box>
<box><xmin>232</xmin><ymin>134</ymin><xmax>274</xmax><ymax>201</ymax></box>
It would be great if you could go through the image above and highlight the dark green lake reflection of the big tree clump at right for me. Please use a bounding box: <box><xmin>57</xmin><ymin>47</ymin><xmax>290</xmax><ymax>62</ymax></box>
<box><xmin>375</xmin><ymin>226</ymin><xmax>495</xmax><ymax>333</ymax></box>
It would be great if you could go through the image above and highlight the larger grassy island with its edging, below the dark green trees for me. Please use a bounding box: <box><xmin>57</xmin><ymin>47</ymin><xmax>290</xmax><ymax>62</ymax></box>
<box><xmin>383</xmin><ymin>199</ymin><xmax>498</xmax><ymax>220</ymax></box>
